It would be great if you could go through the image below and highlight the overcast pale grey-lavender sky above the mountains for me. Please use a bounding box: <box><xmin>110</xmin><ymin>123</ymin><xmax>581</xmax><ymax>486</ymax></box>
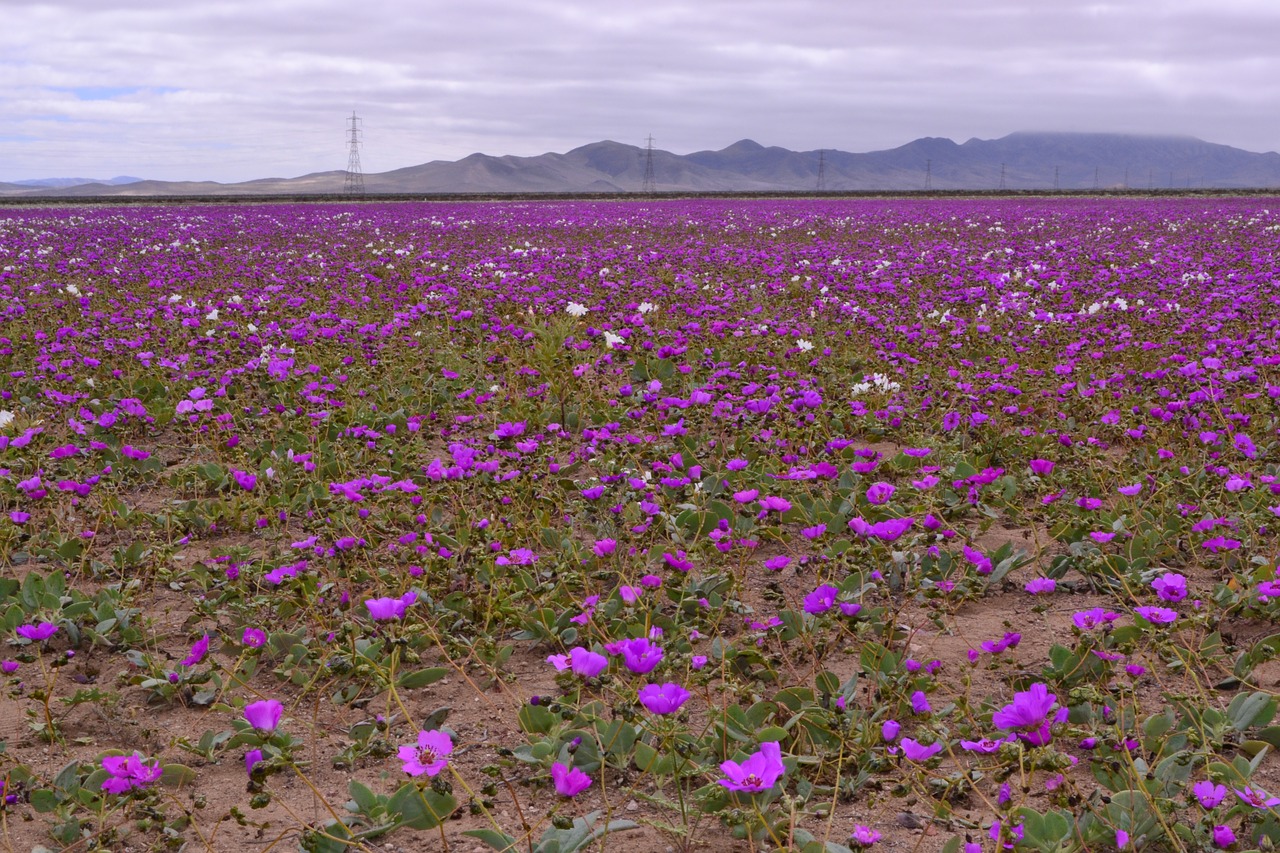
<box><xmin>0</xmin><ymin>0</ymin><xmax>1280</xmax><ymax>182</ymax></box>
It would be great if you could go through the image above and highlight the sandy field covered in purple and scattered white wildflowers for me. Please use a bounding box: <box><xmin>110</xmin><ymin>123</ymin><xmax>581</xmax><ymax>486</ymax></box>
<box><xmin>0</xmin><ymin>197</ymin><xmax>1280</xmax><ymax>853</ymax></box>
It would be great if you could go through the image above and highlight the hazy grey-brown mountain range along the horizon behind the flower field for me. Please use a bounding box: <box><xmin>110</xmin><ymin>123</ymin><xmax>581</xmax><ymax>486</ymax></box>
<box><xmin>0</xmin><ymin>132</ymin><xmax>1280</xmax><ymax>197</ymax></box>
